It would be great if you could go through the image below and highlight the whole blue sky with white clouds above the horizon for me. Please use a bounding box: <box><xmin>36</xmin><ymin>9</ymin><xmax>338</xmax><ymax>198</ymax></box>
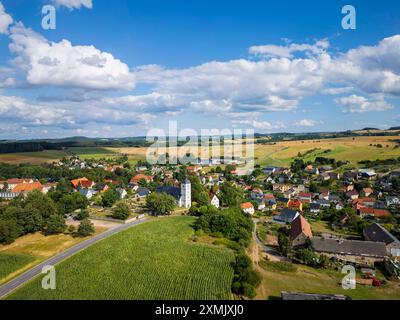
<box><xmin>0</xmin><ymin>0</ymin><xmax>400</xmax><ymax>139</ymax></box>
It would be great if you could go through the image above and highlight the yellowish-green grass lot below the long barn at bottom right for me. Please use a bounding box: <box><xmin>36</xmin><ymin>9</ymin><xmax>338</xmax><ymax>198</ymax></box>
<box><xmin>257</xmin><ymin>263</ymin><xmax>400</xmax><ymax>300</ymax></box>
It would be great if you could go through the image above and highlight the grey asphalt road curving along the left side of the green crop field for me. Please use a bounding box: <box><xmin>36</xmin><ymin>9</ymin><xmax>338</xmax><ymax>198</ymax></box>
<box><xmin>0</xmin><ymin>218</ymin><xmax>150</xmax><ymax>299</ymax></box>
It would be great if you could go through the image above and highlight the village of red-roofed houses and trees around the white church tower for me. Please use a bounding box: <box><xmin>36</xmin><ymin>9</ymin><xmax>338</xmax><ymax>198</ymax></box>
<box><xmin>0</xmin><ymin>152</ymin><xmax>400</xmax><ymax>298</ymax></box>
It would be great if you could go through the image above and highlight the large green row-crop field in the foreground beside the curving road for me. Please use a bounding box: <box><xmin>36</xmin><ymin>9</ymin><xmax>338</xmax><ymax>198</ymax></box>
<box><xmin>9</xmin><ymin>216</ymin><xmax>234</xmax><ymax>300</ymax></box>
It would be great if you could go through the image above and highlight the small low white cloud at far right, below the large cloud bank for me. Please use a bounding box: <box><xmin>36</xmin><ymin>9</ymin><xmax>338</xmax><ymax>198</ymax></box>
<box><xmin>335</xmin><ymin>94</ymin><xmax>393</xmax><ymax>113</ymax></box>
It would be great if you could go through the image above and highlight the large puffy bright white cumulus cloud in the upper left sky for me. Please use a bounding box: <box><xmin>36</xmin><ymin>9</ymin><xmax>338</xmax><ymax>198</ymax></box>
<box><xmin>10</xmin><ymin>23</ymin><xmax>134</xmax><ymax>90</ymax></box>
